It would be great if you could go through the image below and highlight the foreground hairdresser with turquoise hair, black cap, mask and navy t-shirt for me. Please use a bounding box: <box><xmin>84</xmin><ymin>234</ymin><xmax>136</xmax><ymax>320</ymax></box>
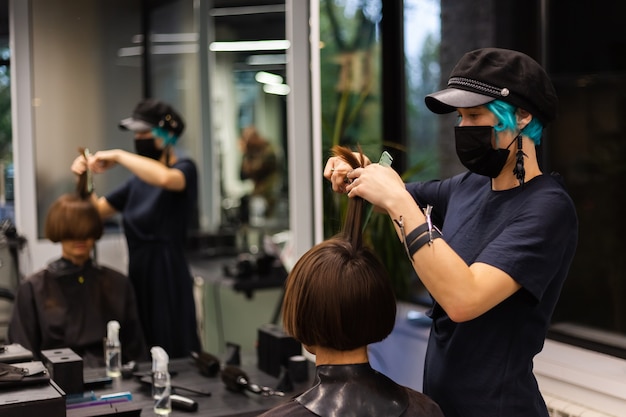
<box><xmin>324</xmin><ymin>48</ymin><xmax>578</xmax><ymax>417</ymax></box>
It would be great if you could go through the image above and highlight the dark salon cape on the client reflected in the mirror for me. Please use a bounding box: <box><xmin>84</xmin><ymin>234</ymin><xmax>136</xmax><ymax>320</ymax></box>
<box><xmin>8</xmin><ymin>259</ymin><xmax>148</xmax><ymax>367</ymax></box>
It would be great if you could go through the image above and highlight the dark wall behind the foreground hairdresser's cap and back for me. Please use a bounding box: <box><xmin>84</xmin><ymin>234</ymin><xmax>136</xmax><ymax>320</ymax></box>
<box><xmin>440</xmin><ymin>0</ymin><xmax>626</xmax><ymax>348</ymax></box>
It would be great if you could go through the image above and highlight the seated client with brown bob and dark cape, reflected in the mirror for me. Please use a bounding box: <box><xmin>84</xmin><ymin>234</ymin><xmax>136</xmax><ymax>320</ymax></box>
<box><xmin>8</xmin><ymin>194</ymin><xmax>149</xmax><ymax>367</ymax></box>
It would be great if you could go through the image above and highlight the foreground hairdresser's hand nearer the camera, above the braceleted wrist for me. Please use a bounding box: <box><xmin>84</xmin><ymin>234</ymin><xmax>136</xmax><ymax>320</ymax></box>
<box><xmin>346</xmin><ymin>164</ymin><xmax>407</xmax><ymax>211</ymax></box>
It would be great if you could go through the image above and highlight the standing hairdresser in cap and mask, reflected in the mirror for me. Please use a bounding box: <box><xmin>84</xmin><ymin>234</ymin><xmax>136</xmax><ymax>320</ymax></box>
<box><xmin>72</xmin><ymin>99</ymin><xmax>200</xmax><ymax>358</ymax></box>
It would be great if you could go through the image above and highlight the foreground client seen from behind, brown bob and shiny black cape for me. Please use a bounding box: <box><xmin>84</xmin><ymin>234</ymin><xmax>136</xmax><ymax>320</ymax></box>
<box><xmin>262</xmin><ymin>148</ymin><xmax>443</xmax><ymax>417</ymax></box>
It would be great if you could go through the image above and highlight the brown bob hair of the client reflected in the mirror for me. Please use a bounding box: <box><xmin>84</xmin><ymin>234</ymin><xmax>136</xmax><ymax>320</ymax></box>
<box><xmin>44</xmin><ymin>193</ymin><xmax>104</xmax><ymax>243</ymax></box>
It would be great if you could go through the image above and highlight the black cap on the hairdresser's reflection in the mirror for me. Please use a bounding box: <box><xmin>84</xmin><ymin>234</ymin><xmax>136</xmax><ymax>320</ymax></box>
<box><xmin>120</xmin><ymin>98</ymin><xmax>185</xmax><ymax>136</ymax></box>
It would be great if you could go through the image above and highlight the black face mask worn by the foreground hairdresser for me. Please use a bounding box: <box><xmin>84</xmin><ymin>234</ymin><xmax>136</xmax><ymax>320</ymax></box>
<box><xmin>454</xmin><ymin>126</ymin><xmax>515</xmax><ymax>178</ymax></box>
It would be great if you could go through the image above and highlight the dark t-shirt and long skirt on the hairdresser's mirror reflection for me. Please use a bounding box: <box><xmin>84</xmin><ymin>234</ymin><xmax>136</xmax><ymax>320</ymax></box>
<box><xmin>106</xmin><ymin>159</ymin><xmax>200</xmax><ymax>358</ymax></box>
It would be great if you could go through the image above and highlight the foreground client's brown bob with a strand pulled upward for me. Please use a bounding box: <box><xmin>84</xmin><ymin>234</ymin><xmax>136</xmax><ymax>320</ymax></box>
<box><xmin>282</xmin><ymin>147</ymin><xmax>396</xmax><ymax>350</ymax></box>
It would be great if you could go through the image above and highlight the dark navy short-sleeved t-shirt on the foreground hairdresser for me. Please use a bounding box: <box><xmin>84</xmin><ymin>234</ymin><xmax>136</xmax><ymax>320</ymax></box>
<box><xmin>407</xmin><ymin>173</ymin><xmax>578</xmax><ymax>417</ymax></box>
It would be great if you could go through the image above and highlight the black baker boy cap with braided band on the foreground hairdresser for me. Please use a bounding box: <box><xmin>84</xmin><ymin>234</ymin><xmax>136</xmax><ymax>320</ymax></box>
<box><xmin>425</xmin><ymin>48</ymin><xmax>558</xmax><ymax>126</ymax></box>
